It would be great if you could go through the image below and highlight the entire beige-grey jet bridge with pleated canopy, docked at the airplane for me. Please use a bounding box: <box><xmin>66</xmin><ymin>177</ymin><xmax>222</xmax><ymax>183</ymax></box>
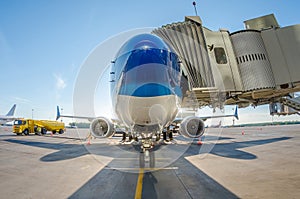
<box><xmin>153</xmin><ymin>14</ymin><xmax>300</xmax><ymax>108</ymax></box>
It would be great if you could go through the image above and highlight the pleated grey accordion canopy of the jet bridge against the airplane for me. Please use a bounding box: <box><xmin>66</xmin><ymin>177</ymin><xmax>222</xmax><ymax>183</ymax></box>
<box><xmin>153</xmin><ymin>17</ymin><xmax>214</xmax><ymax>88</ymax></box>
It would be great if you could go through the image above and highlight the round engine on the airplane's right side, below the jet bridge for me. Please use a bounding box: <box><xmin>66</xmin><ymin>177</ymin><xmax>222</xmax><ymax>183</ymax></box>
<box><xmin>179</xmin><ymin>116</ymin><xmax>205</xmax><ymax>138</ymax></box>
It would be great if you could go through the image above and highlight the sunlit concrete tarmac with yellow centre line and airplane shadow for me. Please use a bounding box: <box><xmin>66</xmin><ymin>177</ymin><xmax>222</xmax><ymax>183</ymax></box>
<box><xmin>0</xmin><ymin>125</ymin><xmax>300</xmax><ymax>199</ymax></box>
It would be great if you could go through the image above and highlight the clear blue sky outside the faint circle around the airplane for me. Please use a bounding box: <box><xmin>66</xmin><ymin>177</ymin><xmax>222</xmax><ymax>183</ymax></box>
<box><xmin>0</xmin><ymin>0</ymin><xmax>300</xmax><ymax>123</ymax></box>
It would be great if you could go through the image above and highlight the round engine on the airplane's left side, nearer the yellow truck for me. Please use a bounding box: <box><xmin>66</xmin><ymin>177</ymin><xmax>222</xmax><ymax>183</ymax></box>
<box><xmin>90</xmin><ymin>117</ymin><xmax>114</xmax><ymax>138</ymax></box>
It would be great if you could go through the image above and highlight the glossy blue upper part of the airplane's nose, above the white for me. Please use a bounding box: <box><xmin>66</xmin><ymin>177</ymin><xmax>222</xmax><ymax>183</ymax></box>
<box><xmin>114</xmin><ymin>34</ymin><xmax>180</xmax><ymax>97</ymax></box>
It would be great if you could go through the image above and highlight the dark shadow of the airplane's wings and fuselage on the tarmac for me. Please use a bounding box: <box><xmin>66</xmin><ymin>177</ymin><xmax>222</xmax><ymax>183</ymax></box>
<box><xmin>5</xmin><ymin>137</ymin><xmax>291</xmax><ymax>199</ymax></box>
